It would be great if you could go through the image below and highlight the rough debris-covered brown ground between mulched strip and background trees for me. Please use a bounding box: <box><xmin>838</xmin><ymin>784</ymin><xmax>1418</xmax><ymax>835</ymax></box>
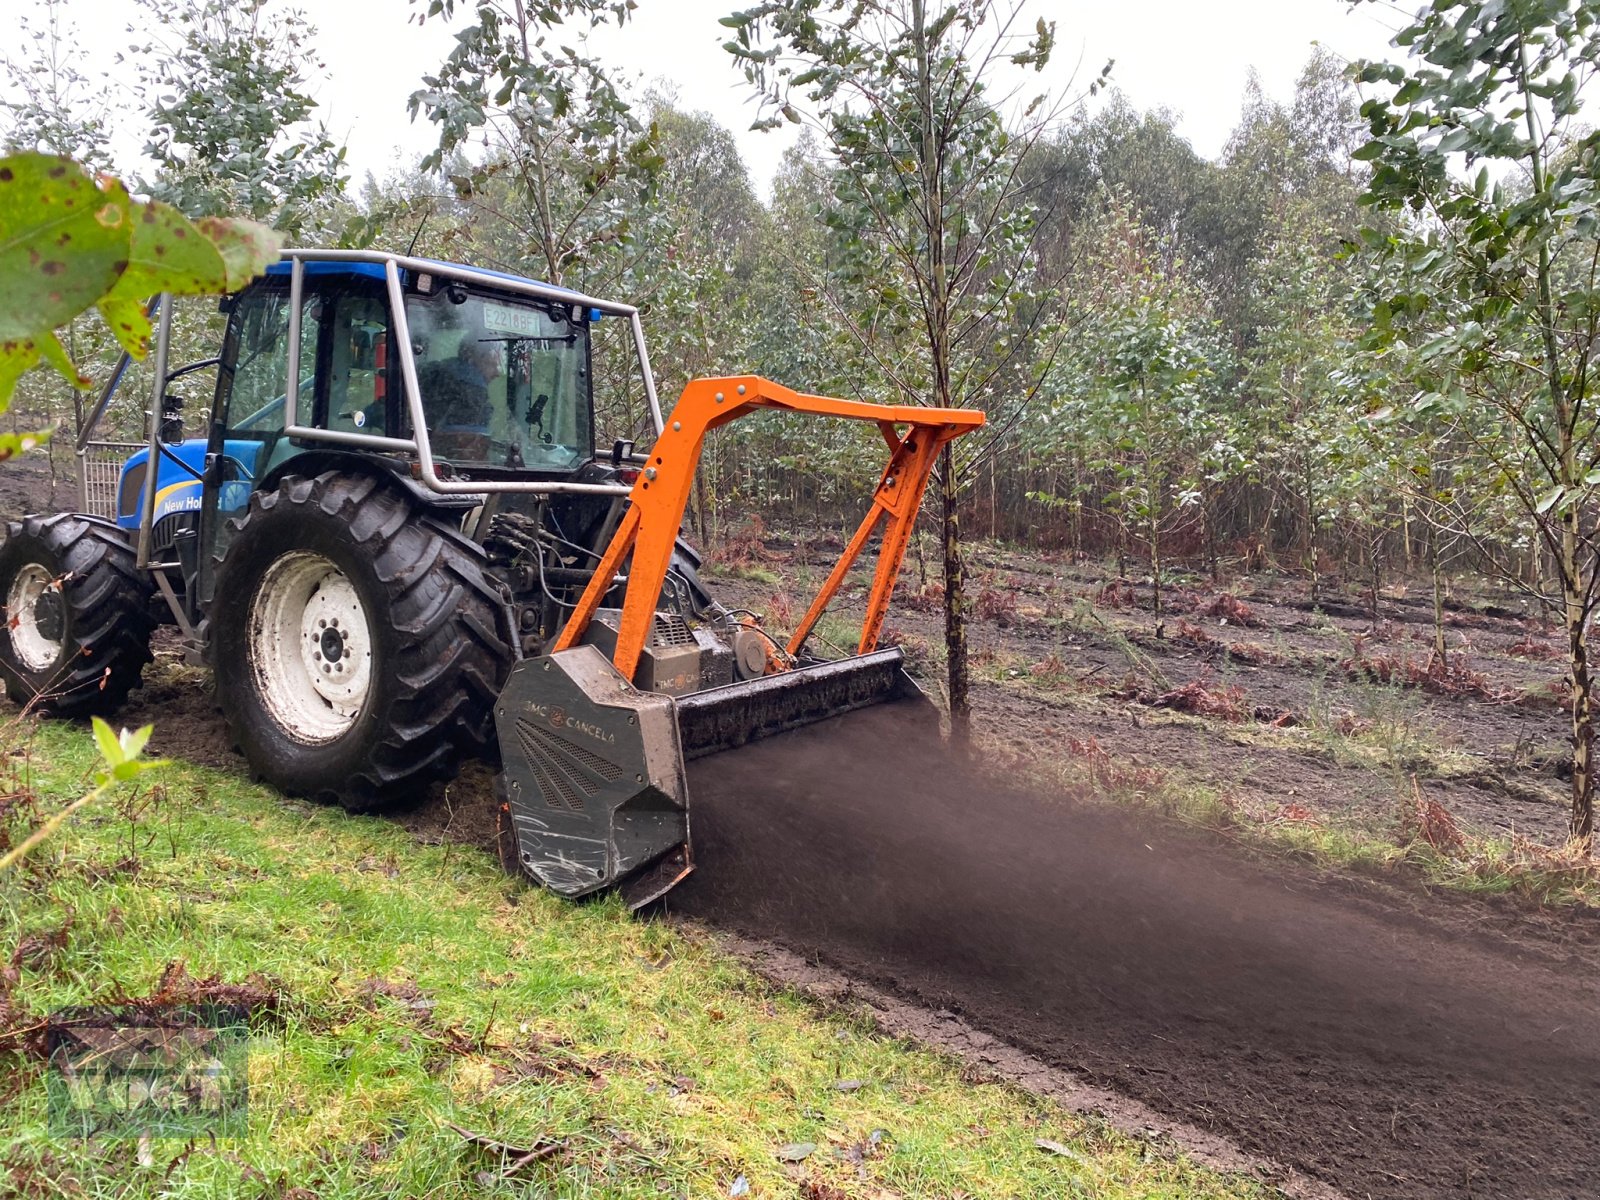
<box><xmin>704</xmin><ymin>542</ymin><xmax>1570</xmax><ymax>845</ymax></box>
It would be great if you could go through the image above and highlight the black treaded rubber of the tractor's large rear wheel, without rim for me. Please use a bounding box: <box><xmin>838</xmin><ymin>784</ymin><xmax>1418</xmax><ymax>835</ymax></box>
<box><xmin>210</xmin><ymin>472</ymin><xmax>517</xmax><ymax>811</ymax></box>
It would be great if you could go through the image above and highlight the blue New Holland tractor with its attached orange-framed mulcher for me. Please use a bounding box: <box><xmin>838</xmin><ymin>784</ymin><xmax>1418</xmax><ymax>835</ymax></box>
<box><xmin>0</xmin><ymin>250</ymin><xmax>982</xmax><ymax>904</ymax></box>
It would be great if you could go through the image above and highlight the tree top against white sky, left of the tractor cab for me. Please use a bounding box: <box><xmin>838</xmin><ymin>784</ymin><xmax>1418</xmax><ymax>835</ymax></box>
<box><xmin>123</xmin><ymin>0</ymin><xmax>346</xmax><ymax>237</ymax></box>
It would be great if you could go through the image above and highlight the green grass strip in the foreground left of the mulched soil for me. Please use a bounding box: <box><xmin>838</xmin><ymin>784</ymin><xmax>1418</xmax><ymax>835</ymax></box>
<box><xmin>0</xmin><ymin>725</ymin><xmax>1262</xmax><ymax>1200</ymax></box>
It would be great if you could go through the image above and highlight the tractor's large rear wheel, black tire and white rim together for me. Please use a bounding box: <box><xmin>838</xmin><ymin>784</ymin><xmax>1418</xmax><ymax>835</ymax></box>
<box><xmin>210</xmin><ymin>472</ymin><xmax>517</xmax><ymax>811</ymax></box>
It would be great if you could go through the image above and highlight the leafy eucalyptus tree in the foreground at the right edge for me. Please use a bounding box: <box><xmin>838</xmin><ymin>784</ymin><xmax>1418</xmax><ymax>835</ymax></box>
<box><xmin>1357</xmin><ymin>0</ymin><xmax>1600</xmax><ymax>845</ymax></box>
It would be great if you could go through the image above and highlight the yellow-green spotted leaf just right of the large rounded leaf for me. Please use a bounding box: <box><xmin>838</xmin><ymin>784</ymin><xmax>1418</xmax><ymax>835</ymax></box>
<box><xmin>99</xmin><ymin>200</ymin><xmax>229</xmax><ymax>360</ymax></box>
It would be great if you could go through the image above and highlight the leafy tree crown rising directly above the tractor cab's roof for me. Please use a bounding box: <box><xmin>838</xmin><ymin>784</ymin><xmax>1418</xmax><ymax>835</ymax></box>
<box><xmin>410</xmin><ymin>0</ymin><xmax>661</xmax><ymax>294</ymax></box>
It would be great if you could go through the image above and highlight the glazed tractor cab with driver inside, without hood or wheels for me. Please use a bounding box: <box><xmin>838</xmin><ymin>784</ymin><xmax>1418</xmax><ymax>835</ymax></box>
<box><xmin>216</xmin><ymin>261</ymin><xmax>600</xmax><ymax>482</ymax></box>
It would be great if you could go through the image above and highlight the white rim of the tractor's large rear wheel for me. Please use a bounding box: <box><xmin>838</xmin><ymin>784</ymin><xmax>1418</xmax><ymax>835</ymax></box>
<box><xmin>250</xmin><ymin>552</ymin><xmax>373</xmax><ymax>746</ymax></box>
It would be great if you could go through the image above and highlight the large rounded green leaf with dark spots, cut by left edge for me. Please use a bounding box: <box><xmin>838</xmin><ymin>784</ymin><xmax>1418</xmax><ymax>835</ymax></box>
<box><xmin>0</xmin><ymin>154</ymin><xmax>131</xmax><ymax>342</ymax></box>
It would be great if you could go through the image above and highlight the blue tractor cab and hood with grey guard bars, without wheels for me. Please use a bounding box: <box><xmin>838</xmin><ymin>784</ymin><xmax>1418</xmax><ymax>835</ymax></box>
<box><xmin>78</xmin><ymin>251</ymin><xmax>659</xmax><ymax>633</ymax></box>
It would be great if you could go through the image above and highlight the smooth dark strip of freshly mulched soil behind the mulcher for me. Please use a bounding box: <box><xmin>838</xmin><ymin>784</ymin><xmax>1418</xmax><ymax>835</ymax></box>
<box><xmin>669</xmin><ymin>709</ymin><xmax>1600</xmax><ymax>1197</ymax></box>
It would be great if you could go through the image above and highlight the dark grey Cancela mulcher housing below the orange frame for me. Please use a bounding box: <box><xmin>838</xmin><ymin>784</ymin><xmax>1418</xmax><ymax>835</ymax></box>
<box><xmin>494</xmin><ymin>646</ymin><xmax>938</xmax><ymax>907</ymax></box>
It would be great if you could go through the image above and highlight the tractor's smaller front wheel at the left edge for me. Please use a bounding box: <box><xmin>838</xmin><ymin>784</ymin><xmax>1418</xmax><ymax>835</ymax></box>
<box><xmin>0</xmin><ymin>512</ymin><xmax>155</xmax><ymax>717</ymax></box>
